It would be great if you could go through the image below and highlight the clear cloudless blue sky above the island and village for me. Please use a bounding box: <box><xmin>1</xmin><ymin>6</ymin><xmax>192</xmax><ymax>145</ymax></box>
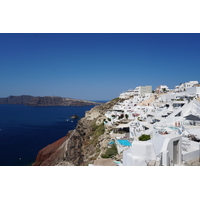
<box><xmin>0</xmin><ymin>33</ymin><xmax>200</xmax><ymax>100</ymax></box>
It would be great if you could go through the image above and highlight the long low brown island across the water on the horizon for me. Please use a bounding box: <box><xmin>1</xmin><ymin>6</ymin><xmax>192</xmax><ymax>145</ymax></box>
<box><xmin>0</xmin><ymin>95</ymin><xmax>101</xmax><ymax>106</ymax></box>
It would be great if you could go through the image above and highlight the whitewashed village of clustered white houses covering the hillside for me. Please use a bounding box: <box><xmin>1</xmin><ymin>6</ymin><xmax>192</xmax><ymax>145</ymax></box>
<box><xmin>104</xmin><ymin>81</ymin><xmax>200</xmax><ymax>166</ymax></box>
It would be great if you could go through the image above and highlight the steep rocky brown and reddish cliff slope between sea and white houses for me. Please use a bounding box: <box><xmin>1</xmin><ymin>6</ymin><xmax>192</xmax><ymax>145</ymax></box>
<box><xmin>34</xmin><ymin>99</ymin><xmax>122</xmax><ymax>166</ymax></box>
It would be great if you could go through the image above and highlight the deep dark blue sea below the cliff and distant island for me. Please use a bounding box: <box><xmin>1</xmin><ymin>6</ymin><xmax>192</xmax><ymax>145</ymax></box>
<box><xmin>0</xmin><ymin>101</ymin><xmax>107</xmax><ymax>166</ymax></box>
